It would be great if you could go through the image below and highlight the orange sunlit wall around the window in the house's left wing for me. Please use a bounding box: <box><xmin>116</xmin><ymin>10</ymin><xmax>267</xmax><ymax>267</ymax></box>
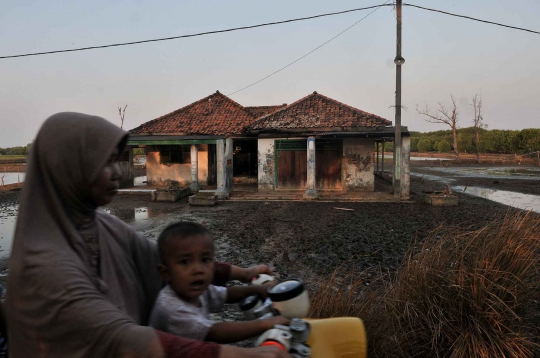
<box><xmin>146</xmin><ymin>145</ymin><xmax>208</xmax><ymax>186</ymax></box>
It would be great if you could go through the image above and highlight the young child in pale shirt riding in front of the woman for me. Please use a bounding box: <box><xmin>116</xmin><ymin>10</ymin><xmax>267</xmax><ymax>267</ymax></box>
<box><xmin>150</xmin><ymin>222</ymin><xmax>289</xmax><ymax>343</ymax></box>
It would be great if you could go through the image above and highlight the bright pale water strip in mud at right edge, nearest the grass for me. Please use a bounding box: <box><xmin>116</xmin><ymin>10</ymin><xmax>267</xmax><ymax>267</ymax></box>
<box><xmin>452</xmin><ymin>186</ymin><xmax>540</xmax><ymax>213</ymax></box>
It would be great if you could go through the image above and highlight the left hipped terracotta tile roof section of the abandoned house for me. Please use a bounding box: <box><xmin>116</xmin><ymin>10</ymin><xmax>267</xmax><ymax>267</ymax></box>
<box><xmin>130</xmin><ymin>91</ymin><xmax>256</xmax><ymax>135</ymax></box>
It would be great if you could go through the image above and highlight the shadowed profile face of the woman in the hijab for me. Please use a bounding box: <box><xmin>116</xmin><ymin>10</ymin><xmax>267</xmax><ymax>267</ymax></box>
<box><xmin>91</xmin><ymin>149</ymin><xmax>122</xmax><ymax>206</ymax></box>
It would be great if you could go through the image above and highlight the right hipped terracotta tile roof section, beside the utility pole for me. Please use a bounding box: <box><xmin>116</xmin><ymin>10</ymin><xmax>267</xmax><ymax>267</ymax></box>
<box><xmin>246</xmin><ymin>92</ymin><xmax>392</xmax><ymax>131</ymax></box>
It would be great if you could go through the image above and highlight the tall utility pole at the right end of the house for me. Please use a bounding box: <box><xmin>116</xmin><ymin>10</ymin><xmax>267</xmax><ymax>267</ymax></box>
<box><xmin>394</xmin><ymin>0</ymin><xmax>405</xmax><ymax>199</ymax></box>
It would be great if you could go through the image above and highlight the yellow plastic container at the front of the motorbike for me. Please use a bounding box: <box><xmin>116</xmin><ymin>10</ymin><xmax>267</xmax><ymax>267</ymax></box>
<box><xmin>305</xmin><ymin>317</ymin><xmax>367</xmax><ymax>358</ymax></box>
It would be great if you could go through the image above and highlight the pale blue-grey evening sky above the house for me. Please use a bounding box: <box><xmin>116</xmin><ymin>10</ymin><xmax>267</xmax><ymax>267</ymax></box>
<box><xmin>0</xmin><ymin>0</ymin><xmax>540</xmax><ymax>148</ymax></box>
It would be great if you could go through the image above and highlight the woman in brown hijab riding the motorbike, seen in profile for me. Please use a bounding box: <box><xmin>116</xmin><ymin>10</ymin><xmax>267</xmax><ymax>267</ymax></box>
<box><xmin>5</xmin><ymin>113</ymin><xmax>289</xmax><ymax>358</ymax></box>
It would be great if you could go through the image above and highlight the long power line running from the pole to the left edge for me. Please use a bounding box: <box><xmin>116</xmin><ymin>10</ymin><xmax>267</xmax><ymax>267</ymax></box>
<box><xmin>0</xmin><ymin>1</ymin><xmax>388</xmax><ymax>59</ymax></box>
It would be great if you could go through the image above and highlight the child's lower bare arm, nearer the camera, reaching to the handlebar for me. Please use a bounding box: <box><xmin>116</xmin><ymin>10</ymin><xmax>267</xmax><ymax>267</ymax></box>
<box><xmin>205</xmin><ymin>316</ymin><xmax>289</xmax><ymax>343</ymax></box>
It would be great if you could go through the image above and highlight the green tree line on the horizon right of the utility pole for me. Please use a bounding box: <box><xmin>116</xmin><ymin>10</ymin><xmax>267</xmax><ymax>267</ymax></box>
<box><xmin>411</xmin><ymin>127</ymin><xmax>540</xmax><ymax>154</ymax></box>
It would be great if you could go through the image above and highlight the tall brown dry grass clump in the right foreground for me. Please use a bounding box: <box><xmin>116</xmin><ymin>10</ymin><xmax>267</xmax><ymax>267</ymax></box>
<box><xmin>310</xmin><ymin>212</ymin><xmax>540</xmax><ymax>358</ymax></box>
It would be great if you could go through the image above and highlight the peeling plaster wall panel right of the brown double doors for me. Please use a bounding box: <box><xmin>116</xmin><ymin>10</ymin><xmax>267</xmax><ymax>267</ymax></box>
<box><xmin>342</xmin><ymin>138</ymin><xmax>375</xmax><ymax>191</ymax></box>
